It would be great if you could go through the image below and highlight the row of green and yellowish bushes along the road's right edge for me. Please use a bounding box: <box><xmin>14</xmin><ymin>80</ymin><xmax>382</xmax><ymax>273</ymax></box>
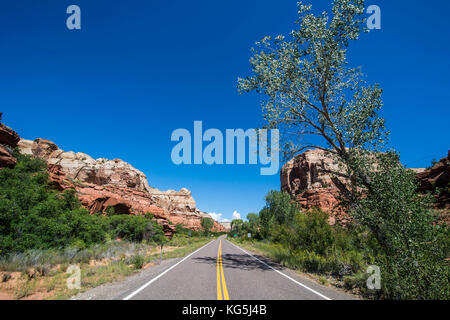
<box><xmin>229</xmin><ymin>191</ymin><xmax>450</xmax><ymax>299</ymax></box>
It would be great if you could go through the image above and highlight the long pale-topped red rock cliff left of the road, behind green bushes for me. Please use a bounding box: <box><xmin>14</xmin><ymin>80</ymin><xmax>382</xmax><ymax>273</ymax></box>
<box><xmin>18</xmin><ymin>139</ymin><xmax>224</xmax><ymax>235</ymax></box>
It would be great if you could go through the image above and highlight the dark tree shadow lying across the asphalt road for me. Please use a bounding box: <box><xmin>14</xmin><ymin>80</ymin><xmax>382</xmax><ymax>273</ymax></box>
<box><xmin>193</xmin><ymin>253</ymin><xmax>282</xmax><ymax>271</ymax></box>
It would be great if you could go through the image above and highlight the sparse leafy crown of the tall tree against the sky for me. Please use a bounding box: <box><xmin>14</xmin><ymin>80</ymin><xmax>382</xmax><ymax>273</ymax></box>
<box><xmin>238</xmin><ymin>0</ymin><xmax>388</xmax><ymax>202</ymax></box>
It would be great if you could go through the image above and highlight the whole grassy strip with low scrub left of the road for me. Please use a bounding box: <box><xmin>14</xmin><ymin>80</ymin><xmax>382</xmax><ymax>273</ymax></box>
<box><xmin>0</xmin><ymin>237</ymin><xmax>212</xmax><ymax>300</ymax></box>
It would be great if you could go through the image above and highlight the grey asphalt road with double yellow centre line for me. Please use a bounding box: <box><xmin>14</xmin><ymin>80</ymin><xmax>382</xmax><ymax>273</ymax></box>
<box><xmin>75</xmin><ymin>237</ymin><xmax>355</xmax><ymax>300</ymax></box>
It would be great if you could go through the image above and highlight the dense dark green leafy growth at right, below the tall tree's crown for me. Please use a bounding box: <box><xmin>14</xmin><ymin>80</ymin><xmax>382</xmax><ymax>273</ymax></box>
<box><xmin>352</xmin><ymin>157</ymin><xmax>450</xmax><ymax>299</ymax></box>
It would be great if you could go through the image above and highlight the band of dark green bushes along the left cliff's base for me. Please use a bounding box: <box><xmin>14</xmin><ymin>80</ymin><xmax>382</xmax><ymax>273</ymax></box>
<box><xmin>0</xmin><ymin>153</ymin><xmax>164</xmax><ymax>255</ymax></box>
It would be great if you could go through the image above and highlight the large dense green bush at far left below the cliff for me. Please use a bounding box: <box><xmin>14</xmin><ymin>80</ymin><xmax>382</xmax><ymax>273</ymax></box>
<box><xmin>0</xmin><ymin>154</ymin><xmax>104</xmax><ymax>254</ymax></box>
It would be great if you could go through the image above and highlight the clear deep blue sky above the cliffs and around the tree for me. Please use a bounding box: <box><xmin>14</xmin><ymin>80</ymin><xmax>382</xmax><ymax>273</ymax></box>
<box><xmin>0</xmin><ymin>0</ymin><xmax>450</xmax><ymax>222</ymax></box>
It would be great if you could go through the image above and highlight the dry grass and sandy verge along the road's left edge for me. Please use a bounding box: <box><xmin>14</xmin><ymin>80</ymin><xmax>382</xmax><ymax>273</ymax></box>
<box><xmin>0</xmin><ymin>238</ymin><xmax>211</xmax><ymax>300</ymax></box>
